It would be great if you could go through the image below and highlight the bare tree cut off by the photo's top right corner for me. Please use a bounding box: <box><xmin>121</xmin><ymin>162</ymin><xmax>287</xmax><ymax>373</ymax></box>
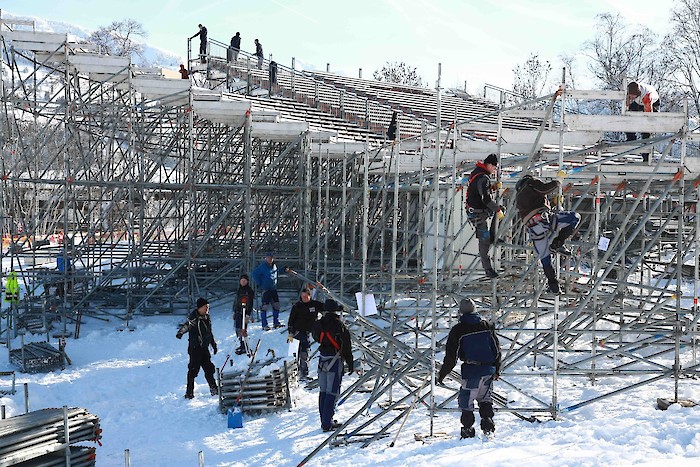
<box><xmin>663</xmin><ymin>0</ymin><xmax>700</xmax><ymax>115</ymax></box>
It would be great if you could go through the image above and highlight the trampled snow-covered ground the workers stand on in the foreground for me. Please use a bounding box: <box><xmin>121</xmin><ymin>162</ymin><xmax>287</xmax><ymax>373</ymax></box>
<box><xmin>0</xmin><ymin>296</ymin><xmax>700</xmax><ymax>466</ymax></box>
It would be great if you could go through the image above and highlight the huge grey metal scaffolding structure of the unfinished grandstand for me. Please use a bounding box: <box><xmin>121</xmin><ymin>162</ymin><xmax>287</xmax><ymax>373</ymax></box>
<box><xmin>0</xmin><ymin>20</ymin><xmax>700</xmax><ymax>443</ymax></box>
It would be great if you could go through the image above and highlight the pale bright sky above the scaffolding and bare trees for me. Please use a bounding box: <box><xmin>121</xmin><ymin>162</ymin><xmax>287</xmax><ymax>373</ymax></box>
<box><xmin>0</xmin><ymin>0</ymin><xmax>674</xmax><ymax>92</ymax></box>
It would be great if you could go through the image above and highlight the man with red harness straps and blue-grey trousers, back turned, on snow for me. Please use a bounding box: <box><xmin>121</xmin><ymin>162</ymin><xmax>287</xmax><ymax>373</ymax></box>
<box><xmin>312</xmin><ymin>299</ymin><xmax>354</xmax><ymax>431</ymax></box>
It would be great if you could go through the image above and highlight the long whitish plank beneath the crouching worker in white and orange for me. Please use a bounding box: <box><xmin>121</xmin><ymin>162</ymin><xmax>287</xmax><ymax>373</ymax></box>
<box><xmin>565</xmin><ymin>112</ymin><xmax>687</xmax><ymax>133</ymax></box>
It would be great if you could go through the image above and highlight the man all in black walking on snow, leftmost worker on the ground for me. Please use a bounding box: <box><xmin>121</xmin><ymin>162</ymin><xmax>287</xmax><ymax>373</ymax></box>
<box><xmin>175</xmin><ymin>298</ymin><xmax>219</xmax><ymax>399</ymax></box>
